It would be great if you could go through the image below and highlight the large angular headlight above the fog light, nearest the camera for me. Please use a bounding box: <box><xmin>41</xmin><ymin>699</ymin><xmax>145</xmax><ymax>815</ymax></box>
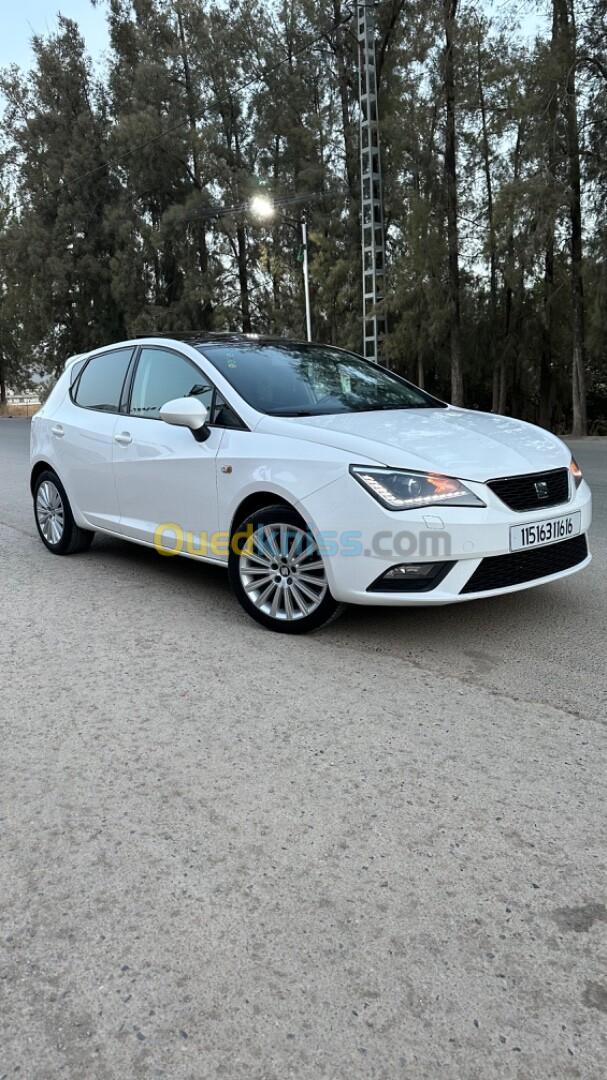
<box><xmin>350</xmin><ymin>465</ymin><xmax>485</xmax><ymax>510</ymax></box>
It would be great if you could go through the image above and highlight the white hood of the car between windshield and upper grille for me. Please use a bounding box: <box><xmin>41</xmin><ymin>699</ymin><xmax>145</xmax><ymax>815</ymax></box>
<box><xmin>257</xmin><ymin>406</ymin><xmax>570</xmax><ymax>483</ymax></box>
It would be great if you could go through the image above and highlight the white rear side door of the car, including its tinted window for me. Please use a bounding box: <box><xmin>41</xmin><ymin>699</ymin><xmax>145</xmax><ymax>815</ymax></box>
<box><xmin>50</xmin><ymin>347</ymin><xmax>134</xmax><ymax>531</ymax></box>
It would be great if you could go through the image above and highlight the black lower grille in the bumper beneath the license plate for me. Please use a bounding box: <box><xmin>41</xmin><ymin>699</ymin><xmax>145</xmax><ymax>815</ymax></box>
<box><xmin>461</xmin><ymin>536</ymin><xmax>588</xmax><ymax>593</ymax></box>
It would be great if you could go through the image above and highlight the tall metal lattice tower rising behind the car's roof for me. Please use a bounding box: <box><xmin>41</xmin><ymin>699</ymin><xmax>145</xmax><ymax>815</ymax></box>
<box><xmin>356</xmin><ymin>2</ymin><xmax>386</xmax><ymax>361</ymax></box>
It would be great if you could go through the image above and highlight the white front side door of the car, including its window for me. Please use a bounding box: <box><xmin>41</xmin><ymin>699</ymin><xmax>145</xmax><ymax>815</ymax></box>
<box><xmin>113</xmin><ymin>346</ymin><xmax>221</xmax><ymax>558</ymax></box>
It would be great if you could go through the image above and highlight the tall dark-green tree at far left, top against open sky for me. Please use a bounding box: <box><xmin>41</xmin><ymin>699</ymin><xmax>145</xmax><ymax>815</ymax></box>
<box><xmin>0</xmin><ymin>17</ymin><xmax>124</xmax><ymax>369</ymax></box>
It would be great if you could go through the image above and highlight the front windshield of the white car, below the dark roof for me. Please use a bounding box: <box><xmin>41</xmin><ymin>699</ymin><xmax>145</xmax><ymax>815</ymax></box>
<box><xmin>199</xmin><ymin>341</ymin><xmax>446</xmax><ymax>416</ymax></box>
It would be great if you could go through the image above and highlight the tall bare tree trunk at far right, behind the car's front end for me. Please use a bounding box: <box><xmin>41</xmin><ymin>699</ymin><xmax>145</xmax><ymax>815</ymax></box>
<box><xmin>554</xmin><ymin>0</ymin><xmax>588</xmax><ymax>436</ymax></box>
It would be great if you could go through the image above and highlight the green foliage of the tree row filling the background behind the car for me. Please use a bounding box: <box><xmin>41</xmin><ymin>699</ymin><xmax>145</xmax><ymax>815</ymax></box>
<box><xmin>0</xmin><ymin>0</ymin><xmax>607</xmax><ymax>428</ymax></box>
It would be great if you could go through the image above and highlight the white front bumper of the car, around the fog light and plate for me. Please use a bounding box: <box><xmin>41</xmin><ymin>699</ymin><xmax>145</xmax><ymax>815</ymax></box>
<box><xmin>300</xmin><ymin>475</ymin><xmax>592</xmax><ymax>607</ymax></box>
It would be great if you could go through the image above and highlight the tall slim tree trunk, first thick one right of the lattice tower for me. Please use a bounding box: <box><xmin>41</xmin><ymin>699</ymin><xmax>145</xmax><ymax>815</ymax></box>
<box><xmin>443</xmin><ymin>0</ymin><xmax>463</xmax><ymax>405</ymax></box>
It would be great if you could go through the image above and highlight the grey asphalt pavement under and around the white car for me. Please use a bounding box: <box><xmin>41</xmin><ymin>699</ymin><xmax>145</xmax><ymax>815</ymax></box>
<box><xmin>0</xmin><ymin>420</ymin><xmax>607</xmax><ymax>1080</ymax></box>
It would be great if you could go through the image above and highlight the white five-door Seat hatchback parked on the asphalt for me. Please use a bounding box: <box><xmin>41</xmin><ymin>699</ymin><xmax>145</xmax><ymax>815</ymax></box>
<box><xmin>31</xmin><ymin>335</ymin><xmax>591</xmax><ymax>633</ymax></box>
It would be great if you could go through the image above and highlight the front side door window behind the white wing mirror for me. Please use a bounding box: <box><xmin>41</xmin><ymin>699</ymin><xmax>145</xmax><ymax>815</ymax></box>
<box><xmin>130</xmin><ymin>349</ymin><xmax>214</xmax><ymax>420</ymax></box>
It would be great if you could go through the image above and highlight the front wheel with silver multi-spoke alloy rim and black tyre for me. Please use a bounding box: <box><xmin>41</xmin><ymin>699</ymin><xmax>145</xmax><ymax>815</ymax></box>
<box><xmin>228</xmin><ymin>504</ymin><xmax>342</xmax><ymax>634</ymax></box>
